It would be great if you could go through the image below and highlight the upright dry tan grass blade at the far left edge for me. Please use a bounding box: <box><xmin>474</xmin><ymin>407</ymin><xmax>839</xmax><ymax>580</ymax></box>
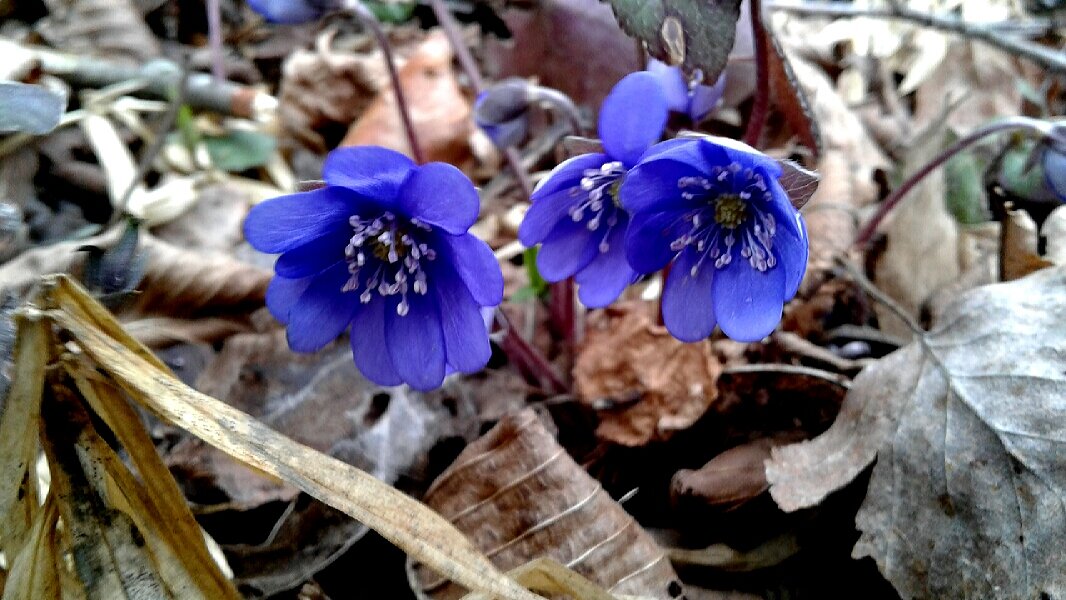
<box><xmin>0</xmin><ymin>317</ymin><xmax>48</xmax><ymax>557</ymax></box>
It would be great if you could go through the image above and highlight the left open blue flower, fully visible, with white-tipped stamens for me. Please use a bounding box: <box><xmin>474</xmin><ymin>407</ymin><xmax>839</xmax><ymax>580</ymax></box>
<box><xmin>244</xmin><ymin>146</ymin><xmax>503</xmax><ymax>390</ymax></box>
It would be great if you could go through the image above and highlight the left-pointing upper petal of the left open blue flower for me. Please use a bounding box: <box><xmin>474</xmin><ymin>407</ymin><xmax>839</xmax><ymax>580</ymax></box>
<box><xmin>244</xmin><ymin>187</ymin><xmax>365</xmax><ymax>254</ymax></box>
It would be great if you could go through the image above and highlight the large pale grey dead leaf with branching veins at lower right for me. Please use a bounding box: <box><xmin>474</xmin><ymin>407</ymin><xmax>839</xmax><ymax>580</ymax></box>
<box><xmin>766</xmin><ymin>267</ymin><xmax>1066</xmax><ymax>598</ymax></box>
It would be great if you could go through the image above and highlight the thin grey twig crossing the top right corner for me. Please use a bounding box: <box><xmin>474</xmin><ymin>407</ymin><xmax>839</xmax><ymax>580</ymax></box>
<box><xmin>767</xmin><ymin>2</ymin><xmax>1066</xmax><ymax>74</ymax></box>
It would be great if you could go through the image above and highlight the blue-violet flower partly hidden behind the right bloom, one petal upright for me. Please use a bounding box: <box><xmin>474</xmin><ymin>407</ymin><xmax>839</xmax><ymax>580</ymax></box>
<box><xmin>518</xmin><ymin>72</ymin><xmax>667</xmax><ymax>308</ymax></box>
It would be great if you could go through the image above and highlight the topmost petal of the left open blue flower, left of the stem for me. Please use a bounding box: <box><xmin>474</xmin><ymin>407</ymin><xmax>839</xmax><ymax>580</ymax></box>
<box><xmin>322</xmin><ymin>146</ymin><xmax>415</xmax><ymax>208</ymax></box>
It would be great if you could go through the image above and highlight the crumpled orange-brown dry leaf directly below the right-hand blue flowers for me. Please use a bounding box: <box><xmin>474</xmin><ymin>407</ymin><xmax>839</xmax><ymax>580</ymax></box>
<box><xmin>574</xmin><ymin>303</ymin><xmax>722</xmax><ymax>445</ymax></box>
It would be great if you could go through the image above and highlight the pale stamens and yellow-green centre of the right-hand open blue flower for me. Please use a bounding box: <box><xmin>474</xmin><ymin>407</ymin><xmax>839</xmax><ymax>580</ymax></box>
<box><xmin>669</xmin><ymin>163</ymin><xmax>777</xmax><ymax>276</ymax></box>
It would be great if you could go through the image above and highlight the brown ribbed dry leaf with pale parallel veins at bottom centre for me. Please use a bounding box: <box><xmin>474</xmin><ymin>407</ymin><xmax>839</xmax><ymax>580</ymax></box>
<box><xmin>417</xmin><ymin>409</ymin><xmax>679</xmax><ymax>599</ymax></box>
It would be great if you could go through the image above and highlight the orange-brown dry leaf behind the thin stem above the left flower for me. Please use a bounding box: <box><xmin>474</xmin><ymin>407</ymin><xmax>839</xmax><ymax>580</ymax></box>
<box><xmin>341</xmin><ymin>30</ymin><xmax>474</xmax><ymax>164</ymax></box>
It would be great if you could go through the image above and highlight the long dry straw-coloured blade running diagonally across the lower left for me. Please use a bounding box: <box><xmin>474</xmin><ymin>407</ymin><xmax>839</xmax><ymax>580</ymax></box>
<box><xmin>45</xmin><ymin>277</ymin><xmax>537</xmax><ymax>600</ymax></box>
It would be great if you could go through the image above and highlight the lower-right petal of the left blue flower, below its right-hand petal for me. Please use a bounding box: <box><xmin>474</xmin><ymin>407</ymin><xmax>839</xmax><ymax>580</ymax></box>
<box><xmin>430</xmin><ymin>269</ymin><xmax>492</xmax><ymax>373</ymax></box>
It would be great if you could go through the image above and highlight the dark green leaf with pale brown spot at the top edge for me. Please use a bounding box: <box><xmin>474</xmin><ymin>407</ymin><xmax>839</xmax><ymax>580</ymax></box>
<box><xmin>609</xmin><ymin>0</ymin><xmax>740</xmax><ymax>81</ymax></box>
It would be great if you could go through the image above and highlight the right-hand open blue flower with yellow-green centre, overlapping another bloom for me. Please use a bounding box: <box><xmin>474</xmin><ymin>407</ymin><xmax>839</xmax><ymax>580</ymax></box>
<box><xmin>621</xmin><ymin>137</ymin><xmax>807</xmax><ymax>342</ymax></box>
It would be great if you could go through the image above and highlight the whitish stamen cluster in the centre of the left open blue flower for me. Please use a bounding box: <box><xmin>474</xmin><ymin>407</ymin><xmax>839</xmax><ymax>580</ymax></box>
<box><xmin>341</xmin><ymin>211</ymin><xmax>437</xmax><ymax>317</ymax></box>
